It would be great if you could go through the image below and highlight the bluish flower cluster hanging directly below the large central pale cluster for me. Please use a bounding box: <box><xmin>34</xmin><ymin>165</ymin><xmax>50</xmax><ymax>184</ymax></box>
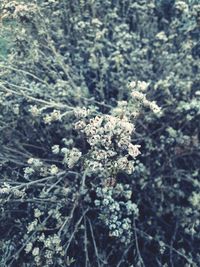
<box><xmin>95</xmin><ymin>183</ymin><xmax>139</xmax><ymax>244</ymax></box>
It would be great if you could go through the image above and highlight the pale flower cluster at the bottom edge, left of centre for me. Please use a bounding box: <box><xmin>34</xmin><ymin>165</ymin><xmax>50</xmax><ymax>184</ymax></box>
<box><xmin>24</xmin><ymin>208</ymin><xmax>64</xmax><ymax>266</ymax></box>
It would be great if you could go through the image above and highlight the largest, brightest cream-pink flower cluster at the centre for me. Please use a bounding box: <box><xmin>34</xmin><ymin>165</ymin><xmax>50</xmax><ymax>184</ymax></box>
<box><xmin>75</xmin><ymin>114</ymin><xmax>140</xmax><ymax>177</ymax></box>
